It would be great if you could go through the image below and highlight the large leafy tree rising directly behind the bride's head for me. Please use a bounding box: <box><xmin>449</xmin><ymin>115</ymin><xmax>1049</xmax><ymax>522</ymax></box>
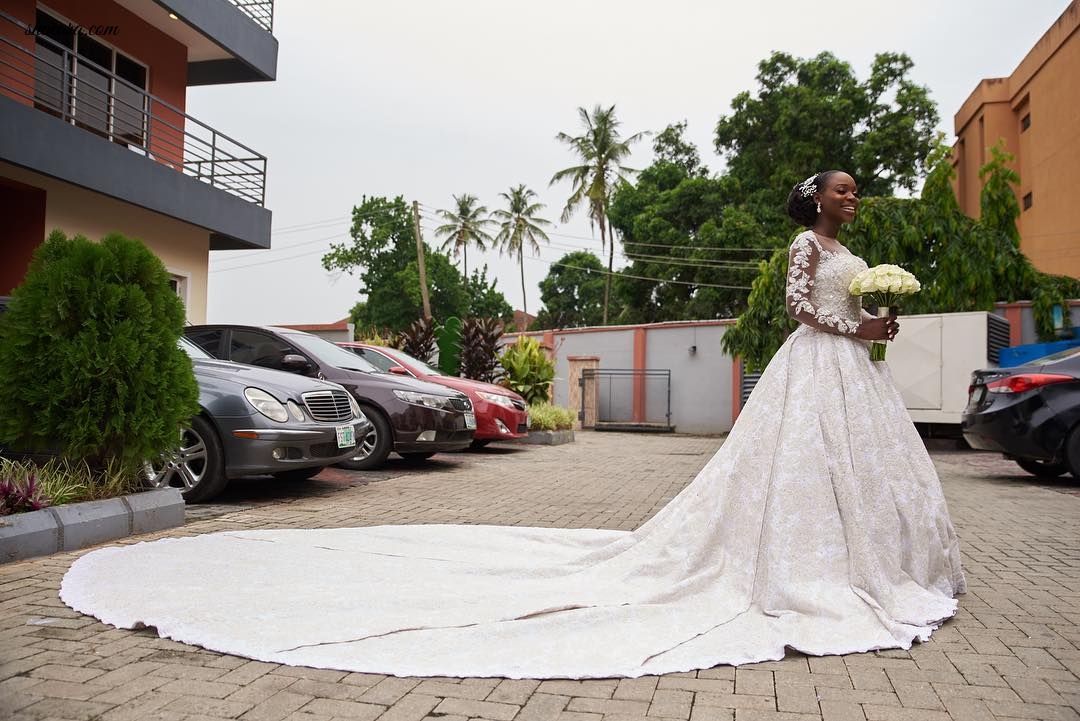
<box><xmin>716</xmin><ymin>52</ymin><xmax>939</xmax><ymax>235</ymax></box>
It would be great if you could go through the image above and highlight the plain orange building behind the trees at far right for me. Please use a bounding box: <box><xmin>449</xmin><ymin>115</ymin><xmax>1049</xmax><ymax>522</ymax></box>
<box><xmin>954</xmin><ymin>1</ymin><xmax>1080</xmax><ymax>277</ymax></box>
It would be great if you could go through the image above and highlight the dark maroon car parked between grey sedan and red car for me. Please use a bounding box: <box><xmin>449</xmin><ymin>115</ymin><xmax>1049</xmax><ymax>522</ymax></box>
<box><xmin>184</xmin><ymin>325</ymin><xmax>476</xmax><ymax>470</ymax></box>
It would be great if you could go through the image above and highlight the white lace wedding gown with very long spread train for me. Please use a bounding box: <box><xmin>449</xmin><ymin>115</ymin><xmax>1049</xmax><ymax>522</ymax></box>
<box><xmin>60</xmin><ymin>233</ymin><xmax>964</xmax><ymax>678</ymax></box>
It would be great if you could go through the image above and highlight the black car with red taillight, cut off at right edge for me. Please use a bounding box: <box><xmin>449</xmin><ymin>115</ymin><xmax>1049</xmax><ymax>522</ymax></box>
<box><xmin>961</xmin><ymin>348</ymin><xmax>1080</xmax><ymax>479</ymax></box>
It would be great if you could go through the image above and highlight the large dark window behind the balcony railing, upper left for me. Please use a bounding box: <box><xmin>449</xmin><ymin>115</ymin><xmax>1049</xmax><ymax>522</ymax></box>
<box><xmin>33</xmin><ymin>10</ymin><xmax>147</xmax><ymax>146</ymax></box>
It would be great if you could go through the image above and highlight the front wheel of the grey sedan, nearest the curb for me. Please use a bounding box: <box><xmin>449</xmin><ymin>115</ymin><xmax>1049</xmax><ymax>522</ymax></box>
<box><xmin>144</xmin><ymin>416</ymin><xmax>229</xmax><ymax>503</ymax></box>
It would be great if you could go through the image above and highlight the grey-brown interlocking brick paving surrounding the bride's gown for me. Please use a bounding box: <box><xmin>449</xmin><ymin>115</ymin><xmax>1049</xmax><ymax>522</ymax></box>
<box><xmin>0</xmin><ymin>433</ymin><xmax>1080</xmax><ymax>721</ymax></box>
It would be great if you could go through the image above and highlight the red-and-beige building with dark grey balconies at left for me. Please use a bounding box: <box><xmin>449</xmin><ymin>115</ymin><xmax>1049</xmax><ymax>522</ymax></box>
<box><xmin>0</xmin><ymin>0</ymin><xmax>278</xmax><ymax>323</ymax></box>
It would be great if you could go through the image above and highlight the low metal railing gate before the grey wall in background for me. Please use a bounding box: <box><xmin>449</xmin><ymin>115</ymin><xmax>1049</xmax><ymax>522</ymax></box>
<box><xmin>578</xmin><ymin>368</ymin><xmax>672</xmax><ymax>427</ymax></box>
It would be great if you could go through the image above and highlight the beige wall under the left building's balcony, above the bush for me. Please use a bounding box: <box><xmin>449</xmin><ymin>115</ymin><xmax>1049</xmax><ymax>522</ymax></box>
<box><xmin>0</xmin><ymin>163</ymin><xmax>210</xmax><ymax>323</ymax></box>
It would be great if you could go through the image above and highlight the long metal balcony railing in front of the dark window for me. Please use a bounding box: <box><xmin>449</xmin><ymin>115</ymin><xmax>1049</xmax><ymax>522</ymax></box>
<box><xmin>0</xmin><ymin>11</ymin><xmax>267</xmax><ymax>205</ymax></box>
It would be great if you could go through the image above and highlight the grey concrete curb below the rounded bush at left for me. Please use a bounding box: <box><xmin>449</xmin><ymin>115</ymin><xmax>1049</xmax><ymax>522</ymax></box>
<box><xmin>0</xmin><ymin>488</ymin><xmax>185</xmax><ymax>563</ymax></box>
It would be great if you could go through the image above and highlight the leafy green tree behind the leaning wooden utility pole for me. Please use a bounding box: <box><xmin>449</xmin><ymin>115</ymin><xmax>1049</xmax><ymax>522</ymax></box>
<box><xmin>322</xmin><ymin>196</ymin><xmax>469</xmax><ymax>331</ymax></box>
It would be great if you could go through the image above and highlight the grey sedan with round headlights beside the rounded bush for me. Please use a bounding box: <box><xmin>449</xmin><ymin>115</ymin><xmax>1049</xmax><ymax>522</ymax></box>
<box><xmin>145</xmin><ymin>338</ymin><xmax>372</xmax><ymax>502</ymax></box>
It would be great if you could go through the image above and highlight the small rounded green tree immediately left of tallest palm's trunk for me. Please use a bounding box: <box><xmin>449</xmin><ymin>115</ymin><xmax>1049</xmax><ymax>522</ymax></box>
<box><xmin>532</xmin><ymin>250</ymin><xmax>605</xmax><ymax>329</ymax></box>
